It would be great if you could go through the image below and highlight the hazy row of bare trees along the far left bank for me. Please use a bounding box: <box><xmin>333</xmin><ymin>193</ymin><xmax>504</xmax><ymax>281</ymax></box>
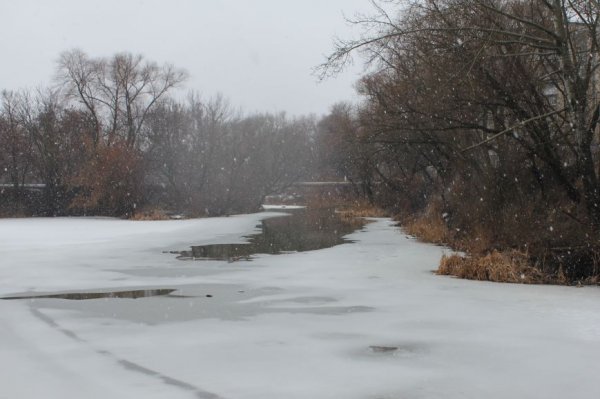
<box><xmin>0</xmin><ymin>50</ymin><xmax>316</xmax><ymax>216</ymax></box>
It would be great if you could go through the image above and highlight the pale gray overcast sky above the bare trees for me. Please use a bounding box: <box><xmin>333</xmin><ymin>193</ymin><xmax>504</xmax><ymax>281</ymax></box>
<box><xmin>0</xmin><ymin>0</ymin><xmax>370</xmax><ymax>114</ymax></box>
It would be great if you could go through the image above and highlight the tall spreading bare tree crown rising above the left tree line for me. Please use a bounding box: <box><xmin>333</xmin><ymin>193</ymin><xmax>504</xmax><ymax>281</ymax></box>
<box><xmin>57</xmin><ymin>50</ymin><xmax>187</xmax><ymax>148</ymax></box>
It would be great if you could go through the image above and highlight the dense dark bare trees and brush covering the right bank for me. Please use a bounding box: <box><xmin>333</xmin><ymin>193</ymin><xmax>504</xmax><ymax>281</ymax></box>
<box><xmin>320</xmin><ymin>0</ymin><xmax>600</xmax><ymax>278</ymax></box>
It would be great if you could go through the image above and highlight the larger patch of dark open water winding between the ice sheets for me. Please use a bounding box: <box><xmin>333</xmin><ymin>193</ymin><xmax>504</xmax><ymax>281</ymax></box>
<box><xmin>178</xmin><ymin>209</ymin><xmax>365</xmax><ymax>262</ymax></box>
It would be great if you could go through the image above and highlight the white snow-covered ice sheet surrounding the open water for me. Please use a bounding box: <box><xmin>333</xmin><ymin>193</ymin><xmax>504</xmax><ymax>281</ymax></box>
<box><xmin>0</xmin><ymin>213</ymin><xmax>600</xmax><ymax>399</ymax></box>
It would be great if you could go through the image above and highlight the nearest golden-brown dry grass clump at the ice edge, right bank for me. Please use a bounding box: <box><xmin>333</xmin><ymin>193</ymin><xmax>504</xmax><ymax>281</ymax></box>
<box><xmin>437</xmin><ymin>250</ymin><xmax>550</xmax><ymax>284</ymax></box>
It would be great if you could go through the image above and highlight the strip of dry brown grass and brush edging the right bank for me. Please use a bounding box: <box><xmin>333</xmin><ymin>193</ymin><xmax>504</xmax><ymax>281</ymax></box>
<box><xmin>398</xmin><ymin>202</ymin><xmax>600</xmax><ymax>285</ymax></box>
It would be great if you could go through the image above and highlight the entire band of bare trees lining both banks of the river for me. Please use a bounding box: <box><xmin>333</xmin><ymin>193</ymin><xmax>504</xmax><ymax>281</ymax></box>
<box><xmin>0</xmin><ymin>0</ymin><xmax>600</xmax><ymax>279</ymax></box>
